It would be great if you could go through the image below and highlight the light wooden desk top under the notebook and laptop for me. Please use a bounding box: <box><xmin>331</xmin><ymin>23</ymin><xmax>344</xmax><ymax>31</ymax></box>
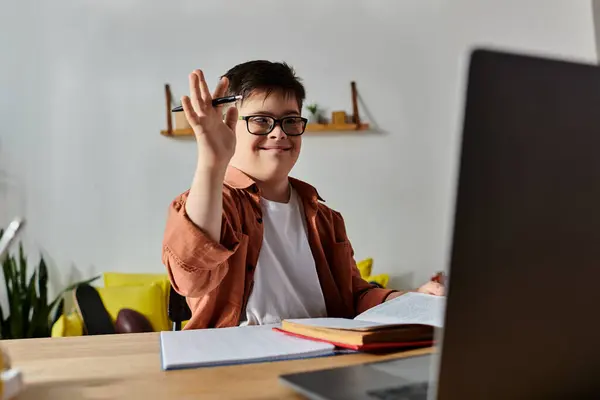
<box><xmin>1</xmin><ymin>333</ymin><xmax>431</xmax><ymax>400</ymax></box>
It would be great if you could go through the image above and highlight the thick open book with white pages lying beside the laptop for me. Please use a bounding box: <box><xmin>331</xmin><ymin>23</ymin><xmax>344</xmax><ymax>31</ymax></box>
<box><xmin>276</xmin><ymin>292</ymin><xmax>446</xmax><ymax>350</ymax></box>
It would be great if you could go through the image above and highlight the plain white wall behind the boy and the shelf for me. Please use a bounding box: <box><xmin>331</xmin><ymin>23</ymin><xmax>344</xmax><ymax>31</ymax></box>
<box><xmin>0</xmin><ymin>0</ymin><xmax>596</xmax><ymax>294</ymax></box>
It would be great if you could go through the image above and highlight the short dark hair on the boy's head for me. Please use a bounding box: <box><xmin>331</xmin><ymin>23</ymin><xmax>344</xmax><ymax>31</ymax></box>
<box><xmin>223</xmin><ymin>60</ymin><xmax>306</xmax><ymax>110</ymax></box>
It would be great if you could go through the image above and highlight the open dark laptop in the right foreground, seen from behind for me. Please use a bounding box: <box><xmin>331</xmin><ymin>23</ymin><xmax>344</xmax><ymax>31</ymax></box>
<box><xmin>281</xmin><ymin>49</ymin><xmax>600</xmax><ymax>400</ymax></box>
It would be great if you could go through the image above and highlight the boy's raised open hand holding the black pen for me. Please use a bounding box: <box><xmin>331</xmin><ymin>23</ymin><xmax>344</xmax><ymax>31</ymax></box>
<box><xmin>181</xmin><ymin>69</ymin><xmax>238</xmax><ymax>169</ymax></box>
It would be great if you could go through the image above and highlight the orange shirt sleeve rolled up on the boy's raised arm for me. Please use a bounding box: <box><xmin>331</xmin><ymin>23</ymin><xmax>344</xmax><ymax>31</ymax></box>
<box><xmin>162</xmin><ymin>190</ymin><xmax>240</xmax><ymax>297</ymax></box>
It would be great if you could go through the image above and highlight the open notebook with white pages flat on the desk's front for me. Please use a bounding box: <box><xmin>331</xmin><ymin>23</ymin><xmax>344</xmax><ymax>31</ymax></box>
<box><xmin>160</xmin><ymin>325</ymin><xmax>336</xmax><ymax>370</ymax></box>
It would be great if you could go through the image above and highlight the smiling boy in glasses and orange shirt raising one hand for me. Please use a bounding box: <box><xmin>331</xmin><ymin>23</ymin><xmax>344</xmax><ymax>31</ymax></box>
<box><xmin>163</xmin><ymin>61</ymin><xmax>443</xmax><ymax>329</ymax></box>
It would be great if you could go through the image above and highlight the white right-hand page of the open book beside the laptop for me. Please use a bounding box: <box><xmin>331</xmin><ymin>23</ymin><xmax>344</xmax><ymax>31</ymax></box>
<box><xmin>355</xmin><ymin>292</ymin><xmax>446</xmax><ymax>328</ymax></box>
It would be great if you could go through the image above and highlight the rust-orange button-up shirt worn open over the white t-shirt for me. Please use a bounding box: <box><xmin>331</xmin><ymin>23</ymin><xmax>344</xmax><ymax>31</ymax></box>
<box><xmin>162</xmin><ymin>167</ymin><xmax>392</xmax><ymax>329</ymax></box>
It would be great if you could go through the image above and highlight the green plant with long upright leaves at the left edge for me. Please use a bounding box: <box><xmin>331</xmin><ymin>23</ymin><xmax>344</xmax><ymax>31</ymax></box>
<box><xmin>0</xmin><ymin>230</ymin><xmax>100</xmax><ymax>339</ymax></box>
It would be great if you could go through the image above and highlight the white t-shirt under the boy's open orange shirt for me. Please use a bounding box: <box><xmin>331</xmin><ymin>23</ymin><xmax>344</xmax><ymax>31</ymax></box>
<box><xmin>242</xmin><ymin>189</ymin><xmax>327</xmax><ymax>325</ymax></box>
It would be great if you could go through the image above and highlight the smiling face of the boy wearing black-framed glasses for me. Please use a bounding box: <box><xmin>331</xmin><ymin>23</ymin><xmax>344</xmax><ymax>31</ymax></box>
<box><xmin>231</xmin><ymin>92</ymin><xmax>302</xmax><ymax>181</ymax></box>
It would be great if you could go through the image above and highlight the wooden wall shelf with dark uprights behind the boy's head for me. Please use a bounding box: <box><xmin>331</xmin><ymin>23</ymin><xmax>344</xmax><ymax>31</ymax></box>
<box><xmin>160</xmin><ymin>82</ymin><xmax>369</xmax><ymax>137</ymax></box>
